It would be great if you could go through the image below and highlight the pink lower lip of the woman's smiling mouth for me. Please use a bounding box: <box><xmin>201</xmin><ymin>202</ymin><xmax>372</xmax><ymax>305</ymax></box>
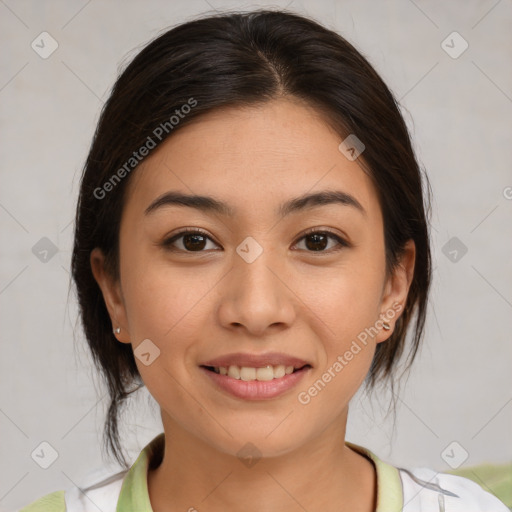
<box><xmin>200</xmin><ymin>366</ymin><xmax>311</xmax><ymax>400</ymax></box>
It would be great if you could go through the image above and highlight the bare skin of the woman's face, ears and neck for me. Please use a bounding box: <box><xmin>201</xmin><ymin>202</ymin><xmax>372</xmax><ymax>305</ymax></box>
<box><xmin>91</xmin><ymin>98</ymin><xmax>415</xmax><ymax>512</ymax></box>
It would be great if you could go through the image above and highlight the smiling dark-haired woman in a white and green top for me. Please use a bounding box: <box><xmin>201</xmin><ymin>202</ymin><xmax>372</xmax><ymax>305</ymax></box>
<box><xmin>19</xmin><ymin>11</ymin><xmax>507</xmax><ymax>512</ymax></box>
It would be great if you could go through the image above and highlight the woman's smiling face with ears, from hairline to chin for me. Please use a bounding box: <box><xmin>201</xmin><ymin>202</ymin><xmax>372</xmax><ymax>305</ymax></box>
<box><xmin>91</xmin><ymin>100</ymin><xmax>414</xmax><ymax>456</ymax></box>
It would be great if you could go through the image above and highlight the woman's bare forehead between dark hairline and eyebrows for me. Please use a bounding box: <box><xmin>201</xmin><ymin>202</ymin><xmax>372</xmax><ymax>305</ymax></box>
<box><xmin>126</xmin><ymin>99</ymin><xmax>380</xmax><ymax>222</ymax></box>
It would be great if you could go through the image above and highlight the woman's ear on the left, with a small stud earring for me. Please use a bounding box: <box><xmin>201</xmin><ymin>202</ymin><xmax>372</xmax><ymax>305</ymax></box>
<box><xmin>90</xmin><ymin>247</ymin><xmax>130</xmax><ymax>343</ymax></box>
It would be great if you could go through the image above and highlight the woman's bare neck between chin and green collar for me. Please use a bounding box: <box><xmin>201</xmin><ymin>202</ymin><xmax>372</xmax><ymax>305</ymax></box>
<box><xmin>148</xmin><ymin>416</ymin><xmax>376</xmax><ymax>512</ymax></box>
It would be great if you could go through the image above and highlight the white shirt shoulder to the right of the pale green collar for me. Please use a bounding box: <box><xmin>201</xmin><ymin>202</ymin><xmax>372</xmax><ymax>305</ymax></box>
<box><xmin>398</xmin><ymin>468</ymin><xmax>510</xmax><ymax>512</ymax></box>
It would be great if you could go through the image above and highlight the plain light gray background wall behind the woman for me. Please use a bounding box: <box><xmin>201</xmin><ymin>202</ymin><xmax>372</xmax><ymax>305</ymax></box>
<box><xmin>0</xmin><ymin>0</ymin><xmax>512</xmax><ymax>510</ymax></box>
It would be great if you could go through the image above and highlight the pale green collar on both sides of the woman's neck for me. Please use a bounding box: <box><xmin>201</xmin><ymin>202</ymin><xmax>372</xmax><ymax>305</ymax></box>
<box><xmin>116</xmin><ymin>432</ymin><xmax>403</xmax><ymax>512</ymax></box>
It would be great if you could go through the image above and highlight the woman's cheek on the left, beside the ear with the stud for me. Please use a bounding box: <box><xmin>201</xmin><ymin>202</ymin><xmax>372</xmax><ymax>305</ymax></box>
<box><xmin>123</xmin><ymin>260</ymin><xmax>208</xmax><ymax>400</ymax></box>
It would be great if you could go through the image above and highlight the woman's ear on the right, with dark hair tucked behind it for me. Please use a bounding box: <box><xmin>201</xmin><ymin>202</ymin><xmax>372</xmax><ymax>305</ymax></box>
<box><xmin>375</xmin><ymin>240</ymin><xmax>416</xmax><ymax>343</ymax></box>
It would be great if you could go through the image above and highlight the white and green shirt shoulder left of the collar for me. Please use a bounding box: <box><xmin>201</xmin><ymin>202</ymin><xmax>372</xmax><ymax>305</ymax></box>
<box><xmin>19</xmin><ymin>471</ymin><xmax>126</xmax><ymax>512</ymax></box>
